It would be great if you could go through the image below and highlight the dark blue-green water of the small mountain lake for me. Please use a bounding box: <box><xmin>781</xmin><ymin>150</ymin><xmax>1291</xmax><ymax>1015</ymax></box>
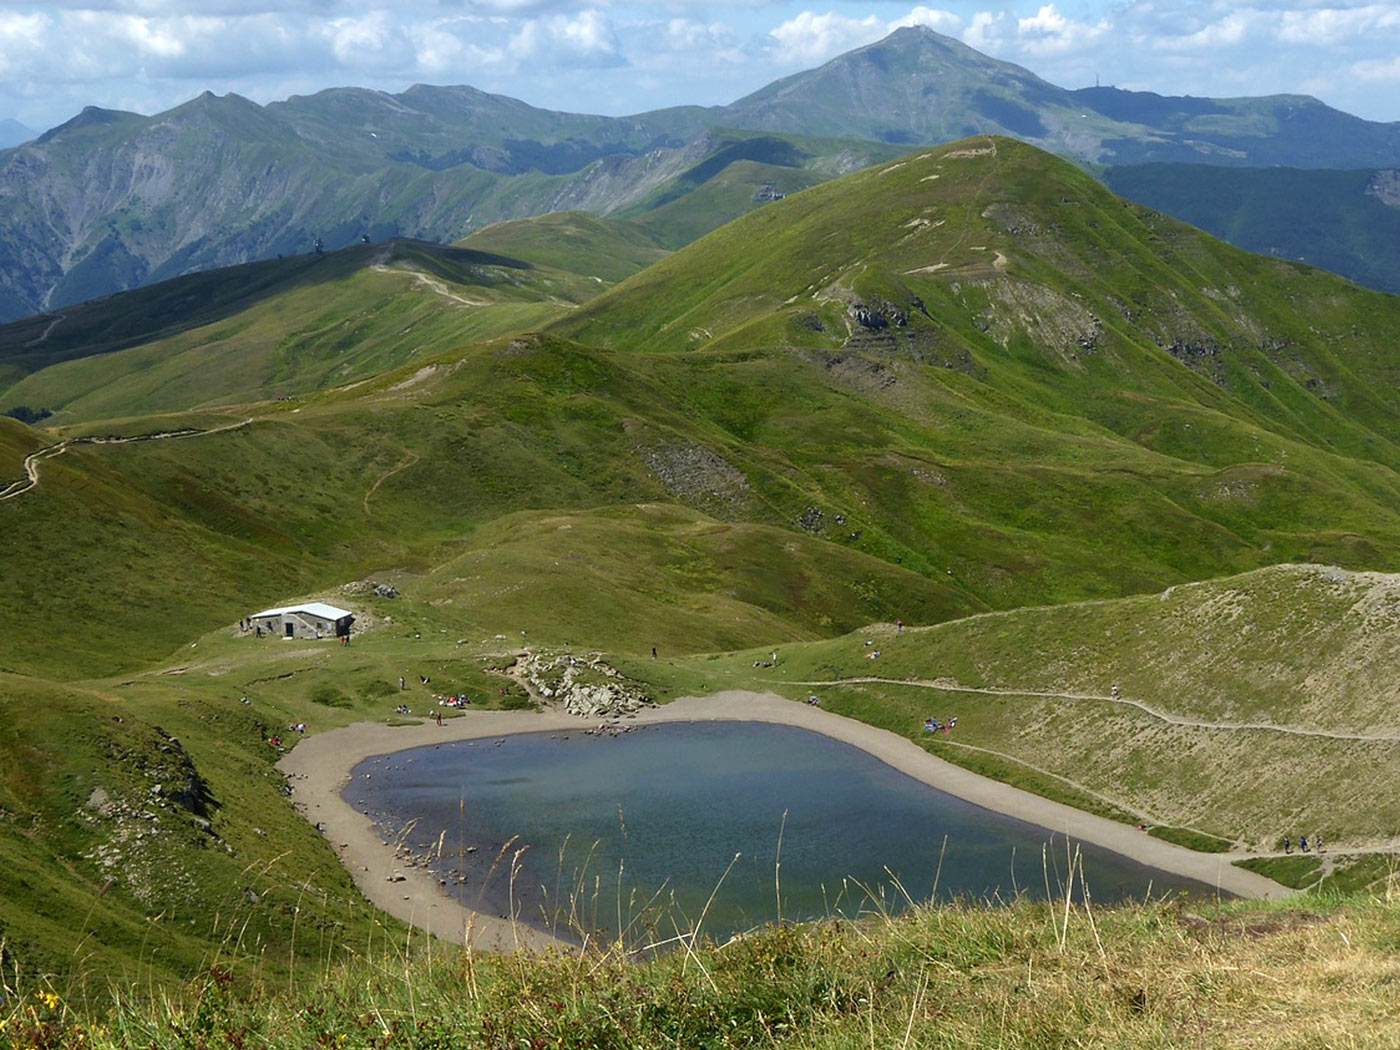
<box><xmin>344</xmin><ymin>722</ymin><xmax>1210</xmax><ymax>941</ymax></box>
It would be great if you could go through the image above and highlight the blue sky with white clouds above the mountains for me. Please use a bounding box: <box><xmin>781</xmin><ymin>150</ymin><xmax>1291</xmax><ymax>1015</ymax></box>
<box><xmin>0</xmin><ymin>0</ymin><xmax>1400</xmax><ymax>130</ymax></box>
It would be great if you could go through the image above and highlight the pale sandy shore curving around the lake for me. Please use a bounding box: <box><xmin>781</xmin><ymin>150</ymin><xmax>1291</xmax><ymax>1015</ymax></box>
<box><xmin>279</xmin><ymin>690</ymin><xmax>1289</xmax><ymax>951</ymax></box>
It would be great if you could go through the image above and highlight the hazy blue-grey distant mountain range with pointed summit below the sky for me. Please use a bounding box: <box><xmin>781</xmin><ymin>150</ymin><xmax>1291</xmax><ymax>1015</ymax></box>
<box><xmin>0</xmin><ymin>28</ymin><xmax>1400</xmax><ymax>319</ymax></box>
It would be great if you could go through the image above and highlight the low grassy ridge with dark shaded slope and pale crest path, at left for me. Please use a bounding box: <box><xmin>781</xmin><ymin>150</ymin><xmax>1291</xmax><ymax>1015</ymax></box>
<box><xmin>0</xmin><ymin>242</ymin><xmax>598</xmax><ymax>426</ymax></box>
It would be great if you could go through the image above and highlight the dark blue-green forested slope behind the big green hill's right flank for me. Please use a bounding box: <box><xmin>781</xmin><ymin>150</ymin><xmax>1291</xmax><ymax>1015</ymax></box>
<box><xmin>1103</xmin><ymin>164</ymin><xmax>1400</xmax><ymax>293</ymax></box>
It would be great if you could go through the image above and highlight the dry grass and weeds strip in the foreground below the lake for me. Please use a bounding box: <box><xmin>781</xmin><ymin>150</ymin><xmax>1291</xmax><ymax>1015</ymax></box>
<box><xmin>8</xmin><ymin>883</ymin><xmax>1400</xmax><ymax>1050</ymax></box>
